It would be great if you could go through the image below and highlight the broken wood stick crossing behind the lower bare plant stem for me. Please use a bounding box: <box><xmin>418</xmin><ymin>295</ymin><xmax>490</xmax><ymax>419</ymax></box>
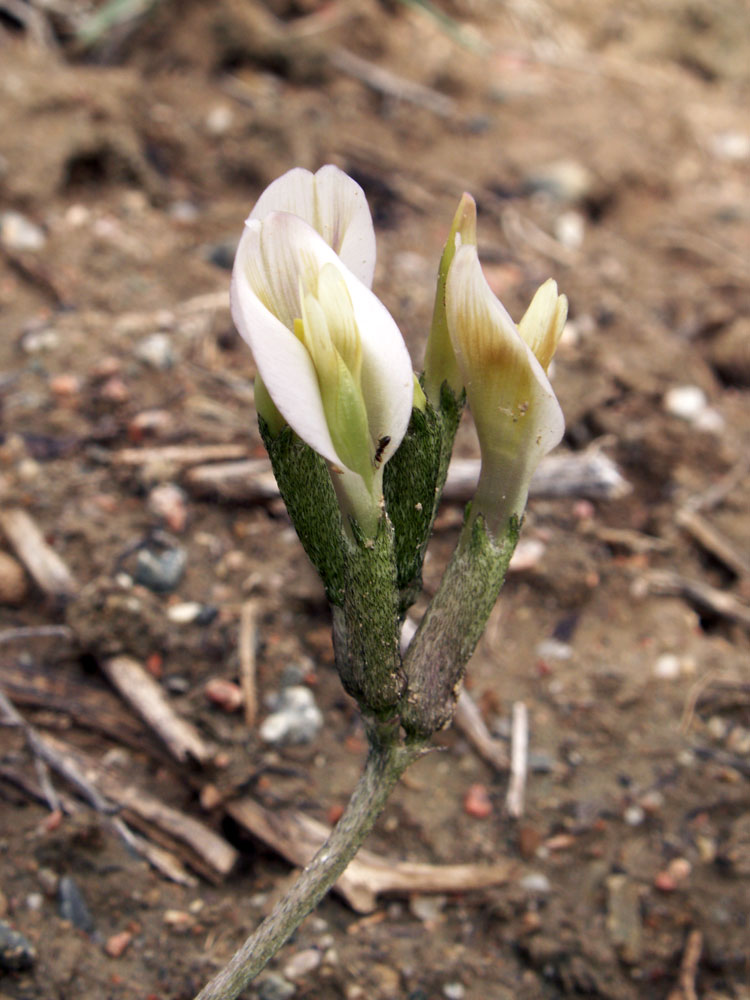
<box><xmin>227</xmin><ymin>798</ymin><xmax>515</xmax><ymax>913</ymax></box>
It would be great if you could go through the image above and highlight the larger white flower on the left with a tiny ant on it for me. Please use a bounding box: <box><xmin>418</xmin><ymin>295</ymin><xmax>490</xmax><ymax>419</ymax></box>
<box><xmin>231</xmin><ymin>167</ymin><xmax>414</xmax><ymax>531</ymax></box>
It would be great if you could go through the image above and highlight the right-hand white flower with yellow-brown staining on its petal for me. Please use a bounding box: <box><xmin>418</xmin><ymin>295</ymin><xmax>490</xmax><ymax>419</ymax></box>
<box><xmin>446</xmin><ymin>245</ymin><xmax>567</xmax><ymax>535</ymax></box>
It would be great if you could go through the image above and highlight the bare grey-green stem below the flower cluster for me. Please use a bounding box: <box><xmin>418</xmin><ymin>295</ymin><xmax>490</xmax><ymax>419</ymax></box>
<box><xmin>195</xmin><ymin>720</ymin><xmax>424</xmax><ymax>1000</ymax></box>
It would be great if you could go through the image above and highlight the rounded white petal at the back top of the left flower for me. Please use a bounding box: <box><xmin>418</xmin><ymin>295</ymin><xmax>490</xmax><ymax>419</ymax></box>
<box><xmin>250</xmin><ymin>164</ymin><xmax>375</xmax><ymax>288</ymax></box>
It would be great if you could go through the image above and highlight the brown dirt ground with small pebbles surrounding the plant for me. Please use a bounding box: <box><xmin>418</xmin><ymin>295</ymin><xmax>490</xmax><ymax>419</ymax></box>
<box><xmin>0</xmin><ymin>0</ymin><xmax>750</xmax><ymax>1000</ymax></box>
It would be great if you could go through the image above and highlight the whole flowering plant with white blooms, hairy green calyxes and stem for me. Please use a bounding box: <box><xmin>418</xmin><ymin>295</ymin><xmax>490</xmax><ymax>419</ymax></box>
<box><xmin>197</xmin><ymin>166</ymin><xmax>567</xmax><ymax>1000</ymax></box>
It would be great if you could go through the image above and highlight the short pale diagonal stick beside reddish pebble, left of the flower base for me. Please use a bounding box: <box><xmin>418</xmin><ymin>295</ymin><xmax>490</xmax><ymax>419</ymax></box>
<box><xmin>101</xmin><ymin>656</ymin><xmax>213</xmax><ymax>764</ymax></box>
